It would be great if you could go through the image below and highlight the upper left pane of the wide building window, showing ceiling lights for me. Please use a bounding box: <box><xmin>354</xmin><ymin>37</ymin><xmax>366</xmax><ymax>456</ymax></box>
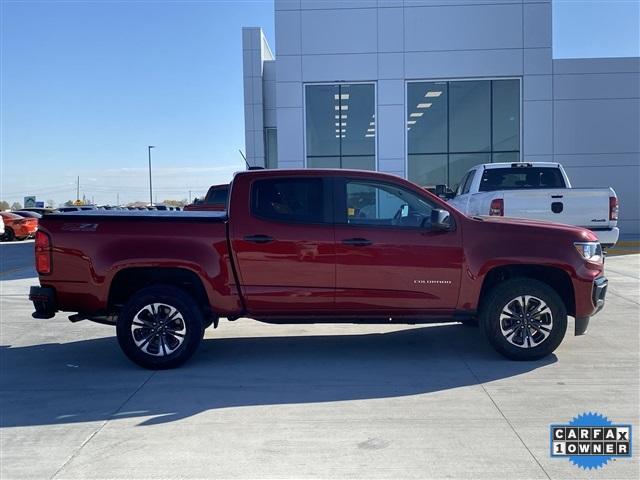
<box><xmin>407</xmin><ymin>82</ymin><xmax>447</xmax><ymax>155</ymax></box>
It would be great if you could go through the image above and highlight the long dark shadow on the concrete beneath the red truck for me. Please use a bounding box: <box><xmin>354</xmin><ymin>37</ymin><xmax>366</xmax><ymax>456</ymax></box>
<box><xmin>0</xmin><ymin>324</ymin><xmax>556</xmax><ymax>427</ymax></box>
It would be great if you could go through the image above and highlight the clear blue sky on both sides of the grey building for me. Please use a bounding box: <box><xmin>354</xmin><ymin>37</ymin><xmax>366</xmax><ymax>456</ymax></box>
<box><xmin>0</xmin><ymin>0</ymin><xmax>640</xmax><ymax>204</ymax></box>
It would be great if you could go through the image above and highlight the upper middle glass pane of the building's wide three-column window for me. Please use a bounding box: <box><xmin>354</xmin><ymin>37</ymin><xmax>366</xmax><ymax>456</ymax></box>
<box><xmin>449</xmin><ymin>80</ymin><xmax>491</xmax><ymax>152</ymax></box>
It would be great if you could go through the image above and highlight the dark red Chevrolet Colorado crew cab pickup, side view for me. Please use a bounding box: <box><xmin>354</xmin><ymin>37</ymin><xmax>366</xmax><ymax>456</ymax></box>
<box><xmin>30</xmin><ymin>170</ymin><xmax>607</xmax><ymax>368</ymax></box>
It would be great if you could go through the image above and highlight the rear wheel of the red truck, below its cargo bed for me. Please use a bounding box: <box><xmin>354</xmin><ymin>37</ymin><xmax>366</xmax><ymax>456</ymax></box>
<box><xmin>116</xmin><ymin>285</ymin><xmax>204</xmax><ymax>370</ymax></box>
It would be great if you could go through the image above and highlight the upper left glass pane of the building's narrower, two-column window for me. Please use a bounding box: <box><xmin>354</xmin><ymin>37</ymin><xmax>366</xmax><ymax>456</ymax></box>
<box><xmin>305</xmin><ymin>85</ymin><xmax>340</xmax><ymax>157</ymax></box>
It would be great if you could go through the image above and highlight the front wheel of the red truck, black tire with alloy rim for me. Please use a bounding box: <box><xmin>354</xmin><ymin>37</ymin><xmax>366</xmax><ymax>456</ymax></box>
<box><xmin>480</xmin><ymin>278</ymin><xmax>567</xmax><ymax>360</ymax></box>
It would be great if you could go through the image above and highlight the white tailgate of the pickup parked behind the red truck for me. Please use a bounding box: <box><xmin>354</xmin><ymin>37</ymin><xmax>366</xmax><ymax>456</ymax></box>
<box><xmin>503</xmin><ymin>188</ymin><xmax>614</xmax><ymax>228</ymax></box>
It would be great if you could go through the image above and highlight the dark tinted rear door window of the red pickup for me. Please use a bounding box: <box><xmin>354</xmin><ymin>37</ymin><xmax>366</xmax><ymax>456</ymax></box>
<box><xmin>251</xmin><ymin>178</ymin><xmax>328</xmax><ymax>223</ymax></box>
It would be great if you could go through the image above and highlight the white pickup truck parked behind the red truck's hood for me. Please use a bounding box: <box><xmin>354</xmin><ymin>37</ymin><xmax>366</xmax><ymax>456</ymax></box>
<box><xmin>449</xmin><ymin>162</ymin><xmax>620</xmax><ymax>247</ymax></box>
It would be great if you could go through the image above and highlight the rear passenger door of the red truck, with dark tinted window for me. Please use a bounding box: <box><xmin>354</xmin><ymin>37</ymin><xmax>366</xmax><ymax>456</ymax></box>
<box><xmin>229</xmin><ymin>172</ymin><xmax>335</xmax><ymax>316</ymax></box>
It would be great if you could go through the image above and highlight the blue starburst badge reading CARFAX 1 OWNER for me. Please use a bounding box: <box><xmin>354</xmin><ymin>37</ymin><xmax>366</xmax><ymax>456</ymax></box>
<box><xmin>551</xmin><ymin>412</ymin><xmax>632</xmax><ymax>470</ymax></box>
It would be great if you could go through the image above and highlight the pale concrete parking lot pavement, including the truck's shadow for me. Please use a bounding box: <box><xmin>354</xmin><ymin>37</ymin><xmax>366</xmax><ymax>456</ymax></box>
<box><xmin>0</xmin><ymin>242</ymin><xmax>640</xmax><ymax>479</ymax></box>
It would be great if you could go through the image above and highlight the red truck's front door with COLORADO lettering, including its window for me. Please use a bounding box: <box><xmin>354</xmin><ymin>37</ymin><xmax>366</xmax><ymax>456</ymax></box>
<box><xmin>335</xmin><ymin>178</ymin><xmax>463</xmax><ymax>316</ymax></box>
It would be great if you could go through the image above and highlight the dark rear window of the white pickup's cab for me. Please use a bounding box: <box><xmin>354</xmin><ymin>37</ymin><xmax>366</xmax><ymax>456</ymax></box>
<box><xmin>479</xmin><ymin>167</ymin><xmax>566</xmax><ymax>192</ymax></box>
